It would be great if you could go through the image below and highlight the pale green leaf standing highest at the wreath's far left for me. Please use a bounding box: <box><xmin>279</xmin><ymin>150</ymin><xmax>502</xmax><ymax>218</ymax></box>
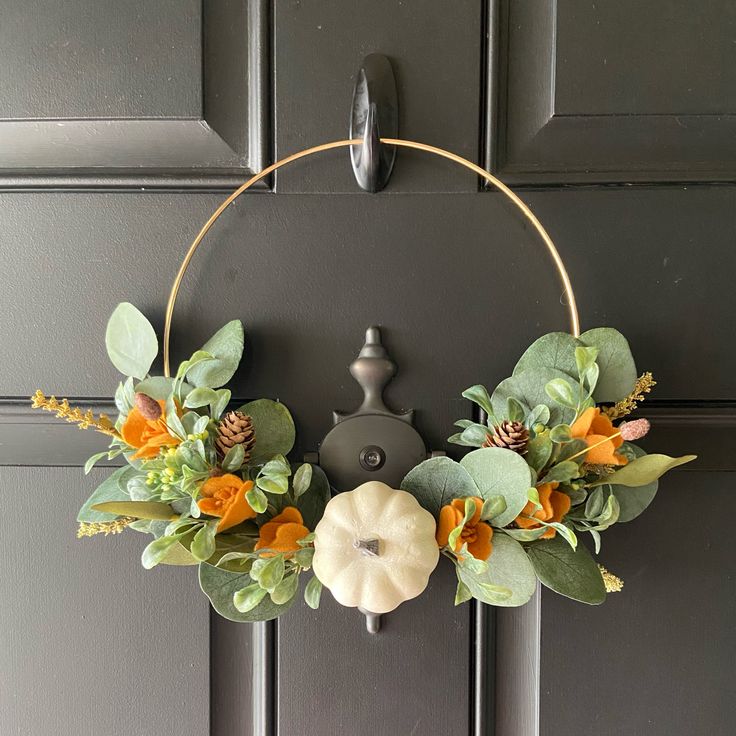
<box><xmin>105</xmin><ymin>302</ymin><xmax>158</xmax><ymax>378</ymax></box>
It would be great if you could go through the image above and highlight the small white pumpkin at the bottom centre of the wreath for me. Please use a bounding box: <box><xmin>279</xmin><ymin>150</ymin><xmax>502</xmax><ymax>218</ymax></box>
<box><xmin>312</xmin><ymin>481</ymin><xmax>440</xmax><ymax>613</ymax></box>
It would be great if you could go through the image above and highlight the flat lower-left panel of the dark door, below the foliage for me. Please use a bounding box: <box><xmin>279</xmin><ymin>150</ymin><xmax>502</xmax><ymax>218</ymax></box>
<box><xmin>0</xmin><ymin>472</ymin><xmax>210</xmax><ymax>736</ymax></box>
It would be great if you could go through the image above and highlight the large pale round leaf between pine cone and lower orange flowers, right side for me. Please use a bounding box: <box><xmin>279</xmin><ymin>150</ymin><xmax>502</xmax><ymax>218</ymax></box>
<box><xmin>460</xmin><ymin>447</ymin><xmax>531</xmax><ymax>526</ymax></box>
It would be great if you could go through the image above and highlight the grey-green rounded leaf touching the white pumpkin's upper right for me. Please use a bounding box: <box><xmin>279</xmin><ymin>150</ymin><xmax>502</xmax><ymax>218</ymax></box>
<box><xmin>401</xmin><ymin>453</ymin><xmax>481</xmax><ymax>518</ymax></box>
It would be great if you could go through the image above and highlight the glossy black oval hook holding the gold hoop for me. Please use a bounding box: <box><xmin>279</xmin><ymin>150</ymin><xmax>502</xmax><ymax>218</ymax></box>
<box><xmin>350</xmin><ymin>54</ymin><xmax>399</xmax><ymax>192</ymax></box>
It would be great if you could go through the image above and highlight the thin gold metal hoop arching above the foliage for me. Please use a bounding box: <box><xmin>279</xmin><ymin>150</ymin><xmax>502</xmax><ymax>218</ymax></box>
<box><xmin>164</xmin><ymin>138</ymin><xmax>580</xmax><ymax>377</ymax></box>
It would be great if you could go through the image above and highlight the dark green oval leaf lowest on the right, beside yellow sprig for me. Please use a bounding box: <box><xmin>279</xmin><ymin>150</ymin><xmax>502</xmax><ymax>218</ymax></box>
<box><xmin>526</xmin><ymin>537</ymin><xmax>606</xmax><ymax>605</ymax></box>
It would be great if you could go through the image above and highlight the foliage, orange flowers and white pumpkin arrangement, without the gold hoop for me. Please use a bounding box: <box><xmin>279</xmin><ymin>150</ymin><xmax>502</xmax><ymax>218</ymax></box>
<box><xmin>32</xmin><ymin>303</ymin><xmax>695</xmax><ymax>621</ymax></box>
